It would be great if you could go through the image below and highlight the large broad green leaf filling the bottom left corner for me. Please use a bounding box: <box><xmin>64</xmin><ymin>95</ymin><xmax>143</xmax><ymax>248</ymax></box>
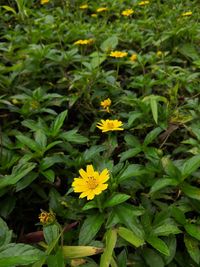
<box><xmin>0</xmin><ymin>243</ymin><xmax>44</xmax><ymax>267</ymax></box>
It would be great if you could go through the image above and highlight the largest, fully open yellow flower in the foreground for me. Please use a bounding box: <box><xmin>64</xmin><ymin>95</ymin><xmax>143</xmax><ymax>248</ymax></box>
<box><xmin>72</xmin><ymin>165</ymin><xmax>110</xmax><ymax>200</ymax></box>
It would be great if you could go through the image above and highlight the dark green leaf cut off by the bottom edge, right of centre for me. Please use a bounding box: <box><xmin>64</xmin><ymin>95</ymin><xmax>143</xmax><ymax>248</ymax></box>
<box><xmin>142</xmin><ymin>248</ymin><xmax>165</xmax><ymax>267</ymax></box>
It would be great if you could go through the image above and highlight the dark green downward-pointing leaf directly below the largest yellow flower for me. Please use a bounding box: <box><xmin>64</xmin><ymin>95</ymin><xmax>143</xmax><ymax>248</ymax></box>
<box><xmin>79</xmin><ymin>213</ymin><xmax>104</xmax><ymax>245</ymax></box>
